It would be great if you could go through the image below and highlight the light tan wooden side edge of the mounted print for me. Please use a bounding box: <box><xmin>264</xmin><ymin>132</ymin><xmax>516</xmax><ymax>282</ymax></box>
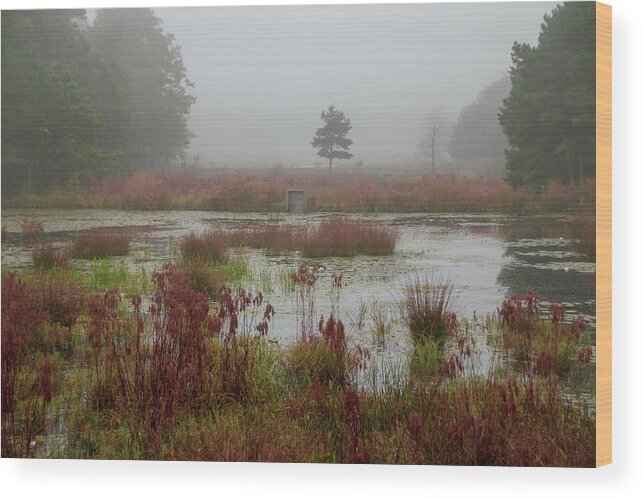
<box><xmin>596</xmin><ymin>2</ymin><xmax>612</xmax><ymax>467</ymax></box>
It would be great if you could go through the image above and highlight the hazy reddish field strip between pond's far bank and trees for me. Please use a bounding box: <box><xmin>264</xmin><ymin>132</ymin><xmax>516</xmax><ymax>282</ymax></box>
<box><xmin>2</xmin><ymin>169</ymin><xmax>596</xmax><ymax>213</ymax></box>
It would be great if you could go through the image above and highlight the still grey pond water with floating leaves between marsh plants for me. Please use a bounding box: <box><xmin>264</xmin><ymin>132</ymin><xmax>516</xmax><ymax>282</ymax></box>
<box><xmin>2</xmin><ymin>210</ymin><xmax>596</xmax><ymax>398</ymax></box>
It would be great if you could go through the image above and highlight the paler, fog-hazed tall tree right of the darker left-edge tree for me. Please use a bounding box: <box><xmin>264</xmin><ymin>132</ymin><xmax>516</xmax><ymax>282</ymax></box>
<box><xmin>89</xmin><ymin>9</ymin><xmax>195</xmax><ymax>166</ymax></box>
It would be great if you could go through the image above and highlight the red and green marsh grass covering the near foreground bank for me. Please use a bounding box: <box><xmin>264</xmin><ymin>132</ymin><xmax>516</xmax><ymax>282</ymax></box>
<box><xmin>2</xmin><ymin>264</ymin><xmax>596</xmax><ymax>466</ymax></box>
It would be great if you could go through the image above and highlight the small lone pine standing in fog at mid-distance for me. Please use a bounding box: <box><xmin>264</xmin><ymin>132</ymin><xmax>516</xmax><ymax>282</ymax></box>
<box><xmin>311</xmin><ymin>106</ymin><xmax>353</xmax><ymax>173</ymax></box>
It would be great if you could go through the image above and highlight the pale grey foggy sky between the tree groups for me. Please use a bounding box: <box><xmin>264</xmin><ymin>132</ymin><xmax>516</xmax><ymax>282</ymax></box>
<box><xmin>108</xmin><ymin>2</ymin><xmax>556</xmax><ymax>166</ymax></box>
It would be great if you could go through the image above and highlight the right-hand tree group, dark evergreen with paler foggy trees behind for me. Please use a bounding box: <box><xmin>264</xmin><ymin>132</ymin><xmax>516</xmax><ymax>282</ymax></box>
<box><xmin>425</xmin><ymin>2</ymin><xmax>596</xmax><ymax>190</ymax></box>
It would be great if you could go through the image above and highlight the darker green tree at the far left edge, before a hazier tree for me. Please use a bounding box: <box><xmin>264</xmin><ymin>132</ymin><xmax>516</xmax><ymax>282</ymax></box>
<box><xmin>2</xmin><ymin>11</ymin><xmax>103</xmax><ymax>193</ymax></box>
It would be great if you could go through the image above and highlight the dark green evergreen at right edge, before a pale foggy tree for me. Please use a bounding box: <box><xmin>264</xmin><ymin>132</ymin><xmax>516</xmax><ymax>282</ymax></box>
<box><xmin>498</xmin><ymin>2</ymin><xmax>596</xmax><ymax>185</ymax></box>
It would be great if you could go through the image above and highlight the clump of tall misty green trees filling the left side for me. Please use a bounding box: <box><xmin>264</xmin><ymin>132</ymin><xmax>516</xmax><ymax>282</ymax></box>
<box><xmin>2</xmin><ymin>9</ymin><xmax>195</xmax><ymax>194</ymax></box>
